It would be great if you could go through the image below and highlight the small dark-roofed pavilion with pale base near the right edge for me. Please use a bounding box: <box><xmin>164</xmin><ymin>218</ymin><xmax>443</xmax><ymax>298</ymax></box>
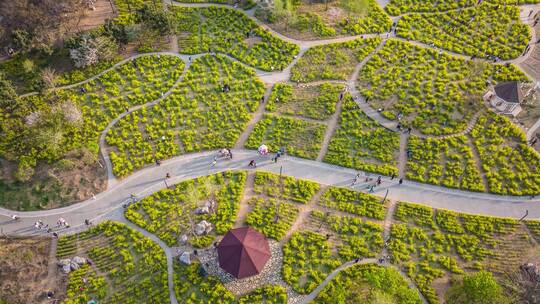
<box><xmin>484</xmin><ymin>81</ymin><xmax>524</xmax><ymax>117</ymax></box>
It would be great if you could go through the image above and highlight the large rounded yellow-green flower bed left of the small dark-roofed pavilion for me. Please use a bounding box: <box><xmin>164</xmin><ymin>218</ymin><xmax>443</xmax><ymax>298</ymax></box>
<box><xmin>357</xmin><ymin>39</ymin><xmax>526</xmax><ymax>135</ymax></box>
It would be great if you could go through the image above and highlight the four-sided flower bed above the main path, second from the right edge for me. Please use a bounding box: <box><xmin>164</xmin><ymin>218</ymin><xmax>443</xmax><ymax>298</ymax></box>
<box><xmin>407</xmin><ymin>136</ymin><xmax>486</xmax><ymax>191</ymax></box>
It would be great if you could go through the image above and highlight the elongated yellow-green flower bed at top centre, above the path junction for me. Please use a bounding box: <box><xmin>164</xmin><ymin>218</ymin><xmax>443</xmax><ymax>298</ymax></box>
<box><xmin>171</xmin><ymin>7</ymin><xmax>300</xmax><ymax>71</ymax></box>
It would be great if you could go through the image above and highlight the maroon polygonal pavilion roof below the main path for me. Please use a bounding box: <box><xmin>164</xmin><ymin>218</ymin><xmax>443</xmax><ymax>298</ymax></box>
<box><xmin>217</xmin><ymin>227</ymin><xmax>271</xmax><ymax>279</ymax></box>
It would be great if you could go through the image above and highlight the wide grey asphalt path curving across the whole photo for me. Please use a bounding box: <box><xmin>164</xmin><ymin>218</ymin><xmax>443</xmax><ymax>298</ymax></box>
<box><xmin>0</xmin><ymin>150</ymin><xmax>540</xmax><ymax>235</ymax></box>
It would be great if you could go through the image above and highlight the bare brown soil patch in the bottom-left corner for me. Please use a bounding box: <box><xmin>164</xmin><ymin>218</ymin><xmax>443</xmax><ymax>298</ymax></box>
<box><xmin>0</xmin><ymin>238</ymin><xmax>66</xmax><ymax>304</ymax></box>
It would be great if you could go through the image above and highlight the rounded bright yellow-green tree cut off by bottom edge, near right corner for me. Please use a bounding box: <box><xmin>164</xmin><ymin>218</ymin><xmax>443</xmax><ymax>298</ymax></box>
<box><xmin>446</xmin><ymin>271</ymin><xmax>508</xmax><ymax>304</ymax></box>
